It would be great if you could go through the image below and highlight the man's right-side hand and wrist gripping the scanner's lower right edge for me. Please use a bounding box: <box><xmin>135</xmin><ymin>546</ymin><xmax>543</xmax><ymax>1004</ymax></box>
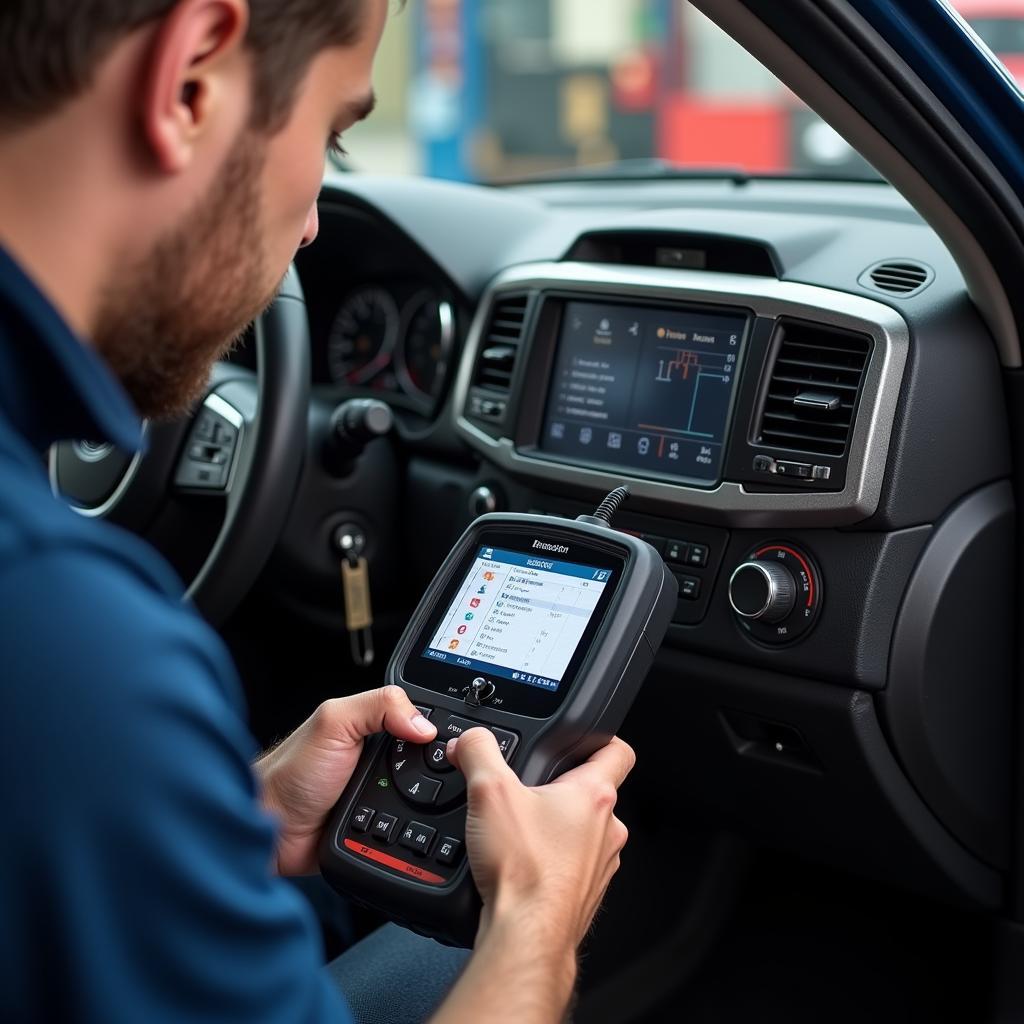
<box><xmin>435</xmin><ymin>729</ymin><xmax>636</xmax><ymax>1024</ymax></box>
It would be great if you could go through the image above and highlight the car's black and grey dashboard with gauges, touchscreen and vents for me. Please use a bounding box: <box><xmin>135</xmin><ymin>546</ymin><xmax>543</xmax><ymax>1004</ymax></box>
<box><xmin>270</xmin><ymin>175</ymin><xmax>1014</xmax><ymax>908</ymax></box>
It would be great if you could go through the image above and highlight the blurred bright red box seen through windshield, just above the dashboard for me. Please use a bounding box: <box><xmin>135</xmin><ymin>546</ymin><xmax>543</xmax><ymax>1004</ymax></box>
<box><xmin>657</xmin><ymin>96</ymin><xmax>790</xmax><ymax>174</ymax></box>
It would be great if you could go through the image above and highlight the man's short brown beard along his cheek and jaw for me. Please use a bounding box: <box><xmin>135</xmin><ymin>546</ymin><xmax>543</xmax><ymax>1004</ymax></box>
<box><xmin>93</xmin><ymin>133</ymin><xmax>276</xmax><ymax>419</ymax></box>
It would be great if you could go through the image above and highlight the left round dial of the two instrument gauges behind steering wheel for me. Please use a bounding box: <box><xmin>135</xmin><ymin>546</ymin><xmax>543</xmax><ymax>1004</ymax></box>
<box><xmin>327</xmin><ymin>288</ymin><xmax>399</xmax><ymax>385</ymax></box>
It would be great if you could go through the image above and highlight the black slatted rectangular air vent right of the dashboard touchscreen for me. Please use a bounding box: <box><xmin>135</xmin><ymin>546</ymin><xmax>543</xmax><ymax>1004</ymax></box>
<box><xmin>757</xmin><ymin>321</ymin><xmax>871</xmax><ymax>458</ymax></box>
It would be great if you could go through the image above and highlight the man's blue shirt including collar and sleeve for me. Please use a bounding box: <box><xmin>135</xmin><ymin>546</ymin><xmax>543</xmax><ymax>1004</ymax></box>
<box><xmin>0</xmin><ymin>251</ymin><xmax>350</xmax><ymax>1024</ymax></box>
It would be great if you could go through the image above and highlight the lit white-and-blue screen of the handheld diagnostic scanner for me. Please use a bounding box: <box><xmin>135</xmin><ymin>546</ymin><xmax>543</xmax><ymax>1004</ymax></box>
<box><xmin>422</xmin><ymin>545</ymin><xmax>614</xmax><ymax>691</ymax></box>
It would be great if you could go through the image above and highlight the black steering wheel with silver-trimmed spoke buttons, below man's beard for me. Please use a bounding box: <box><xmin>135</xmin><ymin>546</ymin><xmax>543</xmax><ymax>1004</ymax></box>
<box><xmin>49</xmin><ymin>266</ymin><xmax>310</xmax><ymax>625</ymax></box>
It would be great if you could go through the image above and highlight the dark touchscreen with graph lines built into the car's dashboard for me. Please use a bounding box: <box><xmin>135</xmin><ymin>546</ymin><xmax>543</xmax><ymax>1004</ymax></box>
<box><xmin>540</xmin><ymin>302</ymin><xmax>746</xmax><ymax>483</ymax></box>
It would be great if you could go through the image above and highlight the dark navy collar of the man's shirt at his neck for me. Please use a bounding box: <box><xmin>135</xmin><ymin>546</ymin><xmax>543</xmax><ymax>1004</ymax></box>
<box><xmin>0</xmin><ymin>247</ymin><xmax>142</xmax><ymax>452</ymax></box>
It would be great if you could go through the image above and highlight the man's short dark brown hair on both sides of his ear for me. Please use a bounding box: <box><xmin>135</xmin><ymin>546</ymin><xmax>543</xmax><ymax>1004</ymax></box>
<box><xmin>0</xmin><ymin>0</ymin><xmax>367</xmax><ymax>130</ymax></box>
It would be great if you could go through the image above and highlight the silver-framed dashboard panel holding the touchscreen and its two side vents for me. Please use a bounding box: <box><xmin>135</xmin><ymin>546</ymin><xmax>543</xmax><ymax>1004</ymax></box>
<box><xmin>456</xmin><ymin>263</ymin><xmax>908</xmax><ymax>526</ymax></box>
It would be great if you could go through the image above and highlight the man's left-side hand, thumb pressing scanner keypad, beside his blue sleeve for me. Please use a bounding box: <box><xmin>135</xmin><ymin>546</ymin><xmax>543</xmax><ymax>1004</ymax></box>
<box><xmin>253</xmin><ymin>686</ymin><xmax>436</xmax><ymax>874</ymax></box>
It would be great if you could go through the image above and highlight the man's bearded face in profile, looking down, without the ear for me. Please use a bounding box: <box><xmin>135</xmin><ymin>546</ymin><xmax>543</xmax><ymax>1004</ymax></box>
<box><xmin>93</xmin><ymin>0</ymin><xmax>387</xmax><ymax>418</ymax></box>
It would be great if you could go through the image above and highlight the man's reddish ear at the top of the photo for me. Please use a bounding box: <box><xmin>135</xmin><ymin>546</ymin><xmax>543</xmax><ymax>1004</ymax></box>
<box><xmin>140</xmin><ymin>0</ymin><xmax>249</xmax><ymax>174</ymax></box>
